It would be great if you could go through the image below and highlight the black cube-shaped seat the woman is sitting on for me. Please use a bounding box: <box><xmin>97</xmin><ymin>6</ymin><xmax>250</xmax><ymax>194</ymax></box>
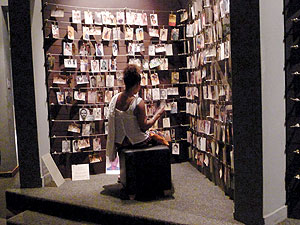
<box><xmin>120</xmin><ymin>145</ymin><xmax>171</xmax><ymax>195</ymax></box>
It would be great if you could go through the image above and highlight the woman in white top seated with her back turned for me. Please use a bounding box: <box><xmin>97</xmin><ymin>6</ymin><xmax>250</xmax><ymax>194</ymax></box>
<box><xmin>106</xmin><ymin>65</ymin><xmax>164</xmax><ymax>161</ymax></box>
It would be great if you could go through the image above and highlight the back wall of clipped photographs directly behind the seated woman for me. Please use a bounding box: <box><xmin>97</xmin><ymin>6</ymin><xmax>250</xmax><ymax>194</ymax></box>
<box><xmin>43</xmin><ymin>1</ymin><xmax>190</xmax><ymax>177</ymax></box>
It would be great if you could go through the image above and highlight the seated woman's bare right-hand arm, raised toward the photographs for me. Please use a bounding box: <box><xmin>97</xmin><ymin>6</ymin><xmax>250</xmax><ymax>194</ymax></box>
<box><xmin>135</xmin><ymin>100</ymin><xmax>165</xmax><ymax>132</ymax></box>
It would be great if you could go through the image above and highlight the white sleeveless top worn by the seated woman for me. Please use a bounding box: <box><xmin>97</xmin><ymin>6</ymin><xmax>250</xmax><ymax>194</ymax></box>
<box><xmin>115</xmin><ymin>97</ymin><xmax>148</xmax><ymax>145</ymax></box>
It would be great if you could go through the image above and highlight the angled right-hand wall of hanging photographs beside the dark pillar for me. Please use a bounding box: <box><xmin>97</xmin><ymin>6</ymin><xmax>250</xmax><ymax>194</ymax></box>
<box><xmin>185</xmin><ymin>0</ymin><xmax>234</xmax><ymax>198</ymax></box>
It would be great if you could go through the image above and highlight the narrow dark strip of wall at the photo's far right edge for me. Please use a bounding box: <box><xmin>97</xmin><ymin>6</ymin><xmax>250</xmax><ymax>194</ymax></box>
<box><xmin>284</xmin><ymin>0</ymin><xmax>300</xmax><ymax>219</ymax></box>
